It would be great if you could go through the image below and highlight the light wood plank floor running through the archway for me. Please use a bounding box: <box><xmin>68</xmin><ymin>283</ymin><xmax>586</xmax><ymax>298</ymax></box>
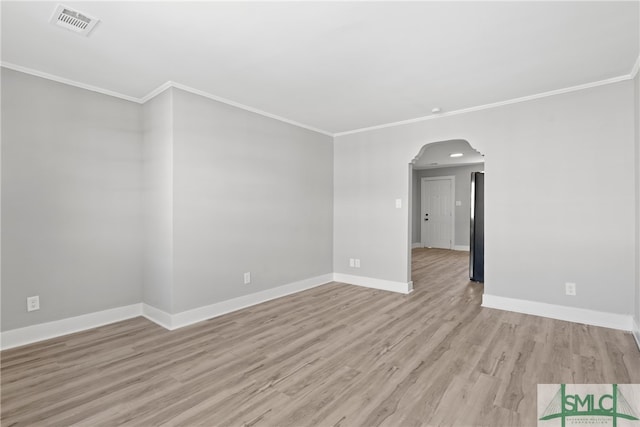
<box><xmin>1</xmin><ymin>249</ymin><xmax>640</xmax><ymax>427</ymax></box>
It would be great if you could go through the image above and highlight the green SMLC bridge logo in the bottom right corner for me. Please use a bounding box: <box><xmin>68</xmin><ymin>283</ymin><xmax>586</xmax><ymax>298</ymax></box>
<box><xmin>540</xmin><ymin>384</ymin><xmax>638</xmax><ymax>427</ymax></box>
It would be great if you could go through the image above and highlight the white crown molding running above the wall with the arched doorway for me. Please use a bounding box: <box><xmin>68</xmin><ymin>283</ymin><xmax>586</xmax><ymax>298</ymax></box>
<box><xmin>333</xmin><ymin>73</ymin><xmax>638</xmax><ymax>137</ymax></box>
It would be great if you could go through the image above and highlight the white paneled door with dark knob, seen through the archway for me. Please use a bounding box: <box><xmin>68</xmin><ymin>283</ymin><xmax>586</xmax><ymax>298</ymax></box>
<box><xmin>420</xmin><ymin>177</ymin><xmax>454</xmax><ymax>249</ymax></box>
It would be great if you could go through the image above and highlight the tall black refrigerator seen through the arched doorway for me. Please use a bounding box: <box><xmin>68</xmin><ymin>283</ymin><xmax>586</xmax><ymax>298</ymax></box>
<box><xmin>469</xmin><ymin>172</ymin><xmax>484</xmax><ymax>282</ymax></box>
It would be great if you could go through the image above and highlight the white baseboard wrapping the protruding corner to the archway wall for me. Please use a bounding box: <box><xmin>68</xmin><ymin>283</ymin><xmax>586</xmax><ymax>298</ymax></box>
<box><xmin>143</xmin><ymin>274</ymin><xmax>333</xmax><ymax>330</ymax></box>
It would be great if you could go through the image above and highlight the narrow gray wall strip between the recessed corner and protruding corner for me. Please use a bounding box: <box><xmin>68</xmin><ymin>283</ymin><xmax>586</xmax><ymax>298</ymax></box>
<box><xmin>142</xmin><ymin>89</ymin><xmax>173</xmax><ymax>313</ymax></box>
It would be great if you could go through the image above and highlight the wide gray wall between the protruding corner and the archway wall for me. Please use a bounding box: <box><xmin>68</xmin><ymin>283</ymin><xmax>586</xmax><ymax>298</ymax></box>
<box><xmin>173</xmin><ymin>90</ymin><xmax>333</xmax><ymax>312</ymax></box>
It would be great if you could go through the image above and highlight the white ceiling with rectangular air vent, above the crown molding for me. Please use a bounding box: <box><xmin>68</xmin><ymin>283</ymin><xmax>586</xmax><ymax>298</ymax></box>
<box><xmin>2</xmin><ymin>1</ymin><xmax>640</xmax><ymax>133</ymax></box>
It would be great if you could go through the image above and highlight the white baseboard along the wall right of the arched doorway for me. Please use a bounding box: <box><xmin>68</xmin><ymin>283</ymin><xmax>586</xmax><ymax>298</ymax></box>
<box><xmin>482</xmin><ymin>294</ymin><xmax>637</xmax><ymax>332</ymax></box>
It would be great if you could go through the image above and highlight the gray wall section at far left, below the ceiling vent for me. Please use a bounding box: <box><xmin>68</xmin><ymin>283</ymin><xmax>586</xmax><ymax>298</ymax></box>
<box><xmin>1</xmin><ymin>68</ymin><xmax>142</xmax><ymax>330</ymax></box>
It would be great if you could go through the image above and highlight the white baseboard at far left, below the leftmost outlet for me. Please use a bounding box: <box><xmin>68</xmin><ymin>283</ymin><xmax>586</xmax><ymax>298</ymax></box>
<box><xmin>0</xmin><ymin>304</ymin><xmax>142</xmax><ymax>350</ymax></box>
